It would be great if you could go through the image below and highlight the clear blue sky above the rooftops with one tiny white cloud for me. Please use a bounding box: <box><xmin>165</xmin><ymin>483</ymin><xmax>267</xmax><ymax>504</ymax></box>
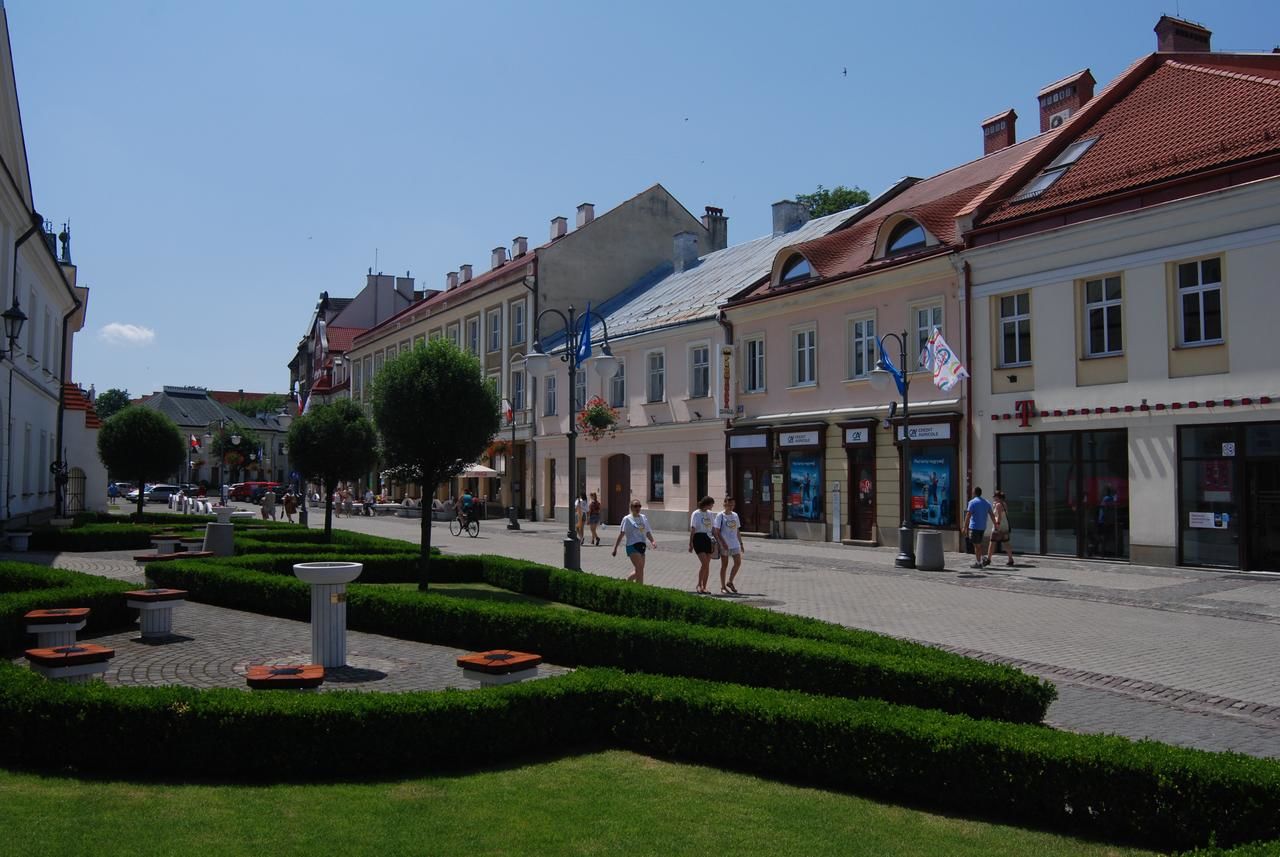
<box><xmin>5</xmin><ymin>0</ymin><xmax>1280</xmax><ymax>395</ymax></box>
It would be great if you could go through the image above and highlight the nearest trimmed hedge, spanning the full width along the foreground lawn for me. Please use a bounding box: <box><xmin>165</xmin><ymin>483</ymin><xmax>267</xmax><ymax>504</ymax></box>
<box><xmin>0</xmin><ymin>664</ymin><xmax>1280</xmax><ymax>853</ymax></box>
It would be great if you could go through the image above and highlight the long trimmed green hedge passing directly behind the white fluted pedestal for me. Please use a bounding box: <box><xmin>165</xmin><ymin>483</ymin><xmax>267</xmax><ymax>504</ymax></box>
<box><xmin>147</xmin><ymin>556</ymin><xmax>1050</xmax><ymax>723</ymax></box>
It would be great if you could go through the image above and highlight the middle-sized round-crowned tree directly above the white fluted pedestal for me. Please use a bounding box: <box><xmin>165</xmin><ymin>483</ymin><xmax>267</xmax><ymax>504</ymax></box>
<box><xmin>289</xmin><ymin>399</ymin><xmax>378</xmax><ymax>542</ymax></box>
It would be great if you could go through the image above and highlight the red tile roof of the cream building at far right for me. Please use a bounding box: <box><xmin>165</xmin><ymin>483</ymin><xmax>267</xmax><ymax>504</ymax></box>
<box><xmin>979</xmin><ymin>54</ymin><xmax>1280</xmax><ymax>225</ymax></box>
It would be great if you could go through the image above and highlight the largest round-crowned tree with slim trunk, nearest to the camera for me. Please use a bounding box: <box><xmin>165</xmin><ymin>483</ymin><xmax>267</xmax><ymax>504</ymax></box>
<box><xmin>372</xmin><ymin>339</ymin><xmax>499</xmax><ymax>590</ymax></box>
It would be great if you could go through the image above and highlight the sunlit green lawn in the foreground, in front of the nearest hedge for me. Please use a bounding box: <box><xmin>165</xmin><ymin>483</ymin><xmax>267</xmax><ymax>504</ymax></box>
<box><xmin>0</xmin><ymin>748</ymin><xmax>1151</xmax><ymax>857</ymax></box>
